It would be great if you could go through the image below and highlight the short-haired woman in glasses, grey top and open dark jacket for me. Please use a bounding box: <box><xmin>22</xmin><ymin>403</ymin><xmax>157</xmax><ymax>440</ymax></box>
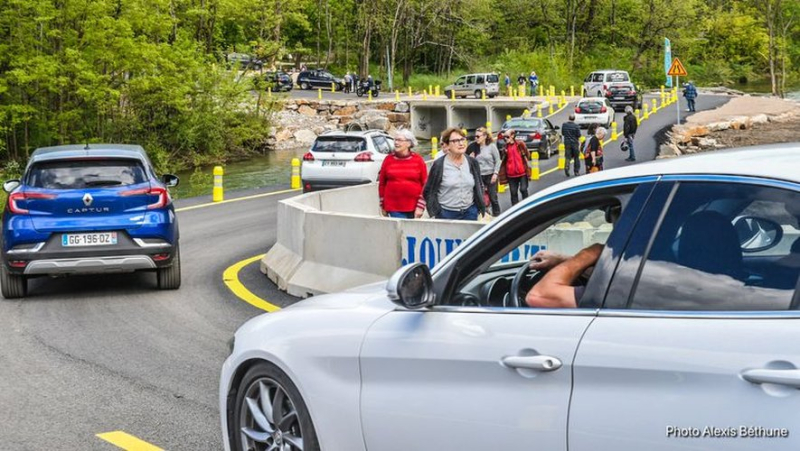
<box><xmin>422</xmin><ymin>127</ymin><xmax>486</xmax><ymax>221</ymax></box>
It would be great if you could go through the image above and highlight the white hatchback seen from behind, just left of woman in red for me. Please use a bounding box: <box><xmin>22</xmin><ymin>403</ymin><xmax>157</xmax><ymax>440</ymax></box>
<box><xmin>300</xmin><ymin>130</ymin><xmax>394</xmax><ymax>192</ymax></box>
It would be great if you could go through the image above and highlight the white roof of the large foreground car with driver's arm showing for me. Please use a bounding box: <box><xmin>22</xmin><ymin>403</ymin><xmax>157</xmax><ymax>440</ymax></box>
<box><xmin>520</xmin><ymin>142</ymin><xmax>800</xmax><ymax>207</ymax></box>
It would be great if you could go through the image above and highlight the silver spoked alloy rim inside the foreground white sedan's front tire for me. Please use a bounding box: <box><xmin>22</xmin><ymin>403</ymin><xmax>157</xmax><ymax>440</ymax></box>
<box><xmin>239</xmin><ymin>377</ymin><xmax>303</xmax><ymax>451</ymax></box>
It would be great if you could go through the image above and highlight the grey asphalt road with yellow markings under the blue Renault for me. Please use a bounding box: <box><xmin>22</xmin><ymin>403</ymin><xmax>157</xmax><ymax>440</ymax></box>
<box><xmin>0</xmin><ymin>96</ymin><xmax>727</xmax><ymax>450</ymax></box>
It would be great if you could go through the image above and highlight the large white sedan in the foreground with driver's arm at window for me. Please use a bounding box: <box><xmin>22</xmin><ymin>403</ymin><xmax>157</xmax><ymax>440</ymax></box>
<box><xmin>219</xmin><ymin>144</ymin><xmax>800</xmax><ymax>451</ymax></box>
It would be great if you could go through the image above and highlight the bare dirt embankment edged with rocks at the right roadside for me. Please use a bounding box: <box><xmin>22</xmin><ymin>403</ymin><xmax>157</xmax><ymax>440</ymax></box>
<box><xmin>659</xmin><ymin>96</ymin><xmax>800</xmax><ymax>158</ymax></box>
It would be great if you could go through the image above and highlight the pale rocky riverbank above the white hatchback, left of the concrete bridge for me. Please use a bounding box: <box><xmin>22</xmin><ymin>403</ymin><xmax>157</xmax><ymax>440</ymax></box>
<box><xmin>271</xmin><ymin>99</ymin><xmax>410</xmax><ymax>150</ymax></box>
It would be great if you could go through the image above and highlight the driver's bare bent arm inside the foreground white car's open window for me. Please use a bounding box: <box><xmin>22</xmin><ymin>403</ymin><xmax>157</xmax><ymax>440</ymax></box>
<box><xmin>525</xmin><ymin>243</ymin><xmax>603</xmax><ymax>308</ymax></box>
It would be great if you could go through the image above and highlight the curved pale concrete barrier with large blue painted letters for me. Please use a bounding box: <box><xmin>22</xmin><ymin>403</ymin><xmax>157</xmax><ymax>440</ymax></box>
<box><xmin>261</xmin><ymin>183</ymin><xmax>611</xmax><ymax>297</ymax></box>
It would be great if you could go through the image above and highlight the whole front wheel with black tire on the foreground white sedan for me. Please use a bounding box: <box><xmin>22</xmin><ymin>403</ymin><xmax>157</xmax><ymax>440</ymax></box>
<box><xmin>228</xmin><ymin>362</ymin><xmax>320</xmax><ymax>451</ymax></box>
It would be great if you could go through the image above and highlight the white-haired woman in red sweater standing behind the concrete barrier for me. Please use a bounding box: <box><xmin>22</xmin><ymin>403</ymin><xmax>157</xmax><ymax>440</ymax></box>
<box><xmin>378</xmin><ymin>130</ymin><xmax>428</xmax><ymax>219</ymax></box>
